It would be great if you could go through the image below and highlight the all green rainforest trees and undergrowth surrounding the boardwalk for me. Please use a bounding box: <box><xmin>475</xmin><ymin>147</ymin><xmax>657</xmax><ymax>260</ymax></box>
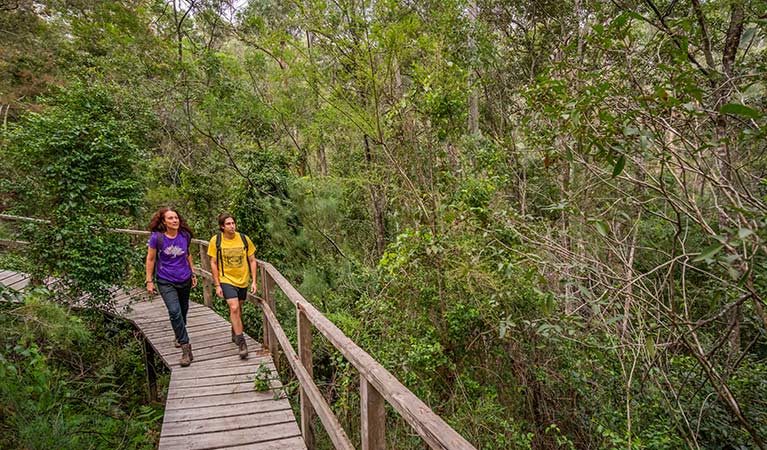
<box><xmin>0</xmin><ymin>0</ymin><xmax>767</xmax><ymax>449</ymax></box>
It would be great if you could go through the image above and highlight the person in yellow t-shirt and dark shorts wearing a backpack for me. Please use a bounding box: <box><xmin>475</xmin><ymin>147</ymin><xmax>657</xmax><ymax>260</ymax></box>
<box><xmin>208</xmin><ymin>213</ymin><xmax>256</xmax><ymax>359</ymax></box>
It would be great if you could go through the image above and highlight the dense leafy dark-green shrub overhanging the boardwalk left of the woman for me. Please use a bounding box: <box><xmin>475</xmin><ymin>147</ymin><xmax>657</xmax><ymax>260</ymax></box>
<box><xmin>5</xmin><ymin>85</ymin><xmax>151</xmax><ymax>302</ymax></box>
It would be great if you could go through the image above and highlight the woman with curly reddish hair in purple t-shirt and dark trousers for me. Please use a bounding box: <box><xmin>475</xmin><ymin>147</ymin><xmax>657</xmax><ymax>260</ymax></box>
<box><xmin>146</xmin><ymin>208</ymin><xmax>197</xmax><ymax>367</ymax></box>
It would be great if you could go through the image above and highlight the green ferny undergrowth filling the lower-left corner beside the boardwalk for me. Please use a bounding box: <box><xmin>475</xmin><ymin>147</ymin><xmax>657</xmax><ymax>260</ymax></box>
<box><xmin>0</xmin><ymin>291</ymin><xmax>162</xmax><ymax>449</ymax></box>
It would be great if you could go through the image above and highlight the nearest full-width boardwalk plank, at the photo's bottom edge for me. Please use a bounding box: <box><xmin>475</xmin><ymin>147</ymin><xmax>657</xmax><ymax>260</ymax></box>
<box><xmin>160</xmin><ymin>422</ymin><xmax>299</xmax><ymax>450</ymax></box>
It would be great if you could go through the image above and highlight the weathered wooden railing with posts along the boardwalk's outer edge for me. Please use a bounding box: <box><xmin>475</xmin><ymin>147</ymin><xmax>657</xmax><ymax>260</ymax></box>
<box><xmin>0</xmin><ymin>214</ymin><xmax>476</xmax><ymax>450</ymax></box>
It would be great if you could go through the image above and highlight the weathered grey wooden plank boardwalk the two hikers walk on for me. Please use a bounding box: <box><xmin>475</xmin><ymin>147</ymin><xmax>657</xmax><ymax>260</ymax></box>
<box><xmin>0</xmin><ymin>270</ymin><xmax>306</xmax><ymax>450</ymax></box>
